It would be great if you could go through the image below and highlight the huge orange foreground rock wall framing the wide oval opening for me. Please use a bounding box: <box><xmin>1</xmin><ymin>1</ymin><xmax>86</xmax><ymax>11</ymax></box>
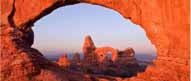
<box><xmin>0</xmin><ymin>0</ymin><xmax>190</xmax><ymax>81</ymax></box>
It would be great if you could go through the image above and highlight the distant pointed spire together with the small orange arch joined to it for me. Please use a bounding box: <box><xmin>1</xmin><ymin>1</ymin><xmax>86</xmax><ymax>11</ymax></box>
<box><xmin>82</xmin><ymin>35</ymin><xmax>118</xmax><ymax>62</ymax></box>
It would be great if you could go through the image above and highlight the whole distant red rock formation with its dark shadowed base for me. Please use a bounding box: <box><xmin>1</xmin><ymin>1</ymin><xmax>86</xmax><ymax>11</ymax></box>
<box><xmin>58</xmin><ymin>36</ymin><xmax>145</xmax><ymax>79</ymax></box>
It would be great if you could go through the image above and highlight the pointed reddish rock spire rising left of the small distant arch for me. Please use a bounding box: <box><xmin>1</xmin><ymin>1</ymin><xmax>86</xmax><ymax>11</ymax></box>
<box><xmin>82</xmin><ymin>35</ymin><xmax>96</xmax><ymax>54</ymax></box>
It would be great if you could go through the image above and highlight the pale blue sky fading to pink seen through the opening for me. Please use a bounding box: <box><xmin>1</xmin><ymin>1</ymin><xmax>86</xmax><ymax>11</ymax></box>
<box><xmin>32</xmin><ymin>3</ymin><xmax>156</xmax><ymax>54</ymax></box>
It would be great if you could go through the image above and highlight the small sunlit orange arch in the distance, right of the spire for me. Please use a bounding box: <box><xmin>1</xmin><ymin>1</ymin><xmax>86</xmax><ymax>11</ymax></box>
<box><xmin>95</xmin><ymin>47</ymin><xmax>118</xmax><ymax>62</ymax></box>
